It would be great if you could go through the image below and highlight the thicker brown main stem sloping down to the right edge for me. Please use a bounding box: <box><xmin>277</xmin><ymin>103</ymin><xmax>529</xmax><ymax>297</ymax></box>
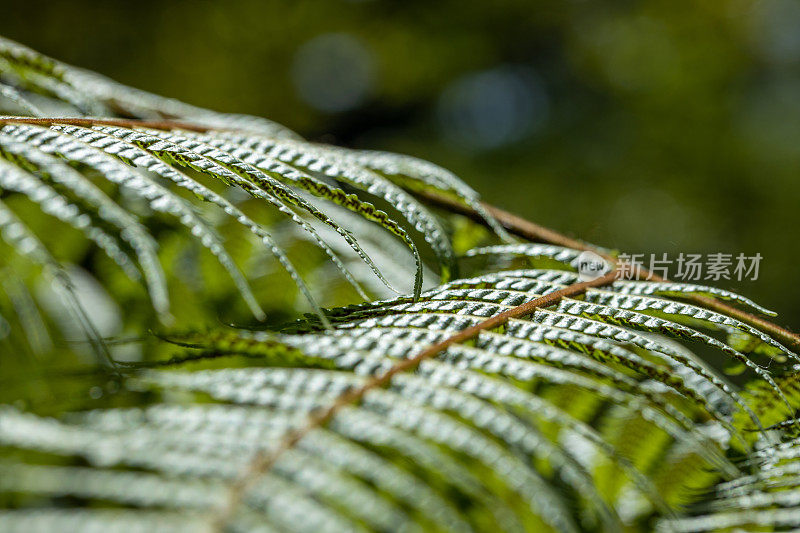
<box><xmin>413</xmin><ymin>187</ymin><xmax>800</xmax><ymax>350</ymax></box>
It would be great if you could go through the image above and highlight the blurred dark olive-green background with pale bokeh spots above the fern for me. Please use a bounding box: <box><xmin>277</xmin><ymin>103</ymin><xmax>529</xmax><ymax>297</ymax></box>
<box><xmin>0</xmin><ymin>0</ymin><xmax>800</xmax><ymax>324</ymax></box>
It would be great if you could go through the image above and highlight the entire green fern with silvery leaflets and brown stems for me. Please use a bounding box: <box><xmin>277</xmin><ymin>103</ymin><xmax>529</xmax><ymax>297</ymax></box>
<box><xmin>0</xmin><ymin>35</ymin><xmax>800</xmax><ymax>532</ymax></box>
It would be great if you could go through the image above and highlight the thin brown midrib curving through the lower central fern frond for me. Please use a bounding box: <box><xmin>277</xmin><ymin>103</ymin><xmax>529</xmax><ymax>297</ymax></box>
<box><xmin>208</xmin><ymin>270</ymin><xmax>617</xmax><ymax>531</ymax></box>
